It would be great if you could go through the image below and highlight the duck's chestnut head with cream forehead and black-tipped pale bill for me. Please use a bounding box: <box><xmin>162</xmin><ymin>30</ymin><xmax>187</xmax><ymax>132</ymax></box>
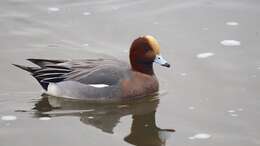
<box><xmin>130</xmin><ymin>35</ymin><xmax>170</xmax><ymax>74</ymax></box>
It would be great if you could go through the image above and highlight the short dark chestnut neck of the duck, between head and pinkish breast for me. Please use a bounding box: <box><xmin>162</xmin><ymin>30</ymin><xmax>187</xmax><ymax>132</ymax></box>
<box><xmin>131</xmin><ymin>62</ymin><xmax>154</xmax><ymax>75</ymax></box>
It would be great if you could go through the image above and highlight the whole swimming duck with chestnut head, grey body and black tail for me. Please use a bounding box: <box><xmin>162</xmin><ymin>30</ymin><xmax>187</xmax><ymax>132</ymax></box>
<box><xmin>13</xmin><ymin>35</ymin><xmax>170</xmax><ymax>102</ymax></box>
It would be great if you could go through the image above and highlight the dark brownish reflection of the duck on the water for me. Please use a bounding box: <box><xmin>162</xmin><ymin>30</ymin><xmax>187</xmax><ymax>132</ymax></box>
<box><xmin>34</xmin><ymin>95</ymin><xmax>175</xmax><ymax>146</ymax></box>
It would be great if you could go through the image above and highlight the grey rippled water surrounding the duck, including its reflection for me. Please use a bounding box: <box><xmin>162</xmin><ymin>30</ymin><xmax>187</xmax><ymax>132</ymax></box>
<box><xmin>0</xmin><ymin>0</ymin><xmax>260</xmax><ymax>146</ymax></box>
